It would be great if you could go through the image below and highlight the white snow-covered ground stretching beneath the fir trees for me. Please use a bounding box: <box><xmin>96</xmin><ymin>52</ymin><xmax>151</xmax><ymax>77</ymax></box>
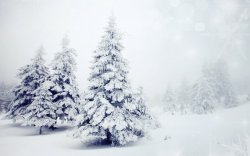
<box><xmin>0</xmin><ymin>103</ymin><xmax>250</xmax><ymax>156</ymax></box>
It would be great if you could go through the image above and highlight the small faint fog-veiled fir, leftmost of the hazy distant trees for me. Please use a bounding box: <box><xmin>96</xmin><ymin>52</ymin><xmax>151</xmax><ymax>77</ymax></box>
<box><xmin>163</xmin><ymin>86</ymin><xmax>177</xmax><ymax>115</ymax></box>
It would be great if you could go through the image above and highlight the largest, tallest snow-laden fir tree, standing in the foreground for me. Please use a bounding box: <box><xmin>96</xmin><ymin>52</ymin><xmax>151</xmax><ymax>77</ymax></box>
<box><xmin>74</xmin><ymin>17</ymin><xmax>150</xmax><ymax>145</ymax></box>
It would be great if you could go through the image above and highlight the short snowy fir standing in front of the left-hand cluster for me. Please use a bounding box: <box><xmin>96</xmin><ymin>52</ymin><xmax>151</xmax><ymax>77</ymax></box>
<box><xmin>24</xmin><ymin>81</ymin><xmax>57</xmax><ymax>134</ymax></box>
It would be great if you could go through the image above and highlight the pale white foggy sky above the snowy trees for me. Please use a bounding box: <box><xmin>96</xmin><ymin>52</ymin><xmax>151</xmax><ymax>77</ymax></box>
<box><xmin>0</xmin><ymin>0</ymin><xmax>250</xmax><ymax>102</ymax></box>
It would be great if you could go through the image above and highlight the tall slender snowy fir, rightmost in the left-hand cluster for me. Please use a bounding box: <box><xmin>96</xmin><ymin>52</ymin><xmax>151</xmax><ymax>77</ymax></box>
<box><xmin>50</xmin><ymin>36</ymin><xmax>80</xmax><ymax>122</ymax></box>
